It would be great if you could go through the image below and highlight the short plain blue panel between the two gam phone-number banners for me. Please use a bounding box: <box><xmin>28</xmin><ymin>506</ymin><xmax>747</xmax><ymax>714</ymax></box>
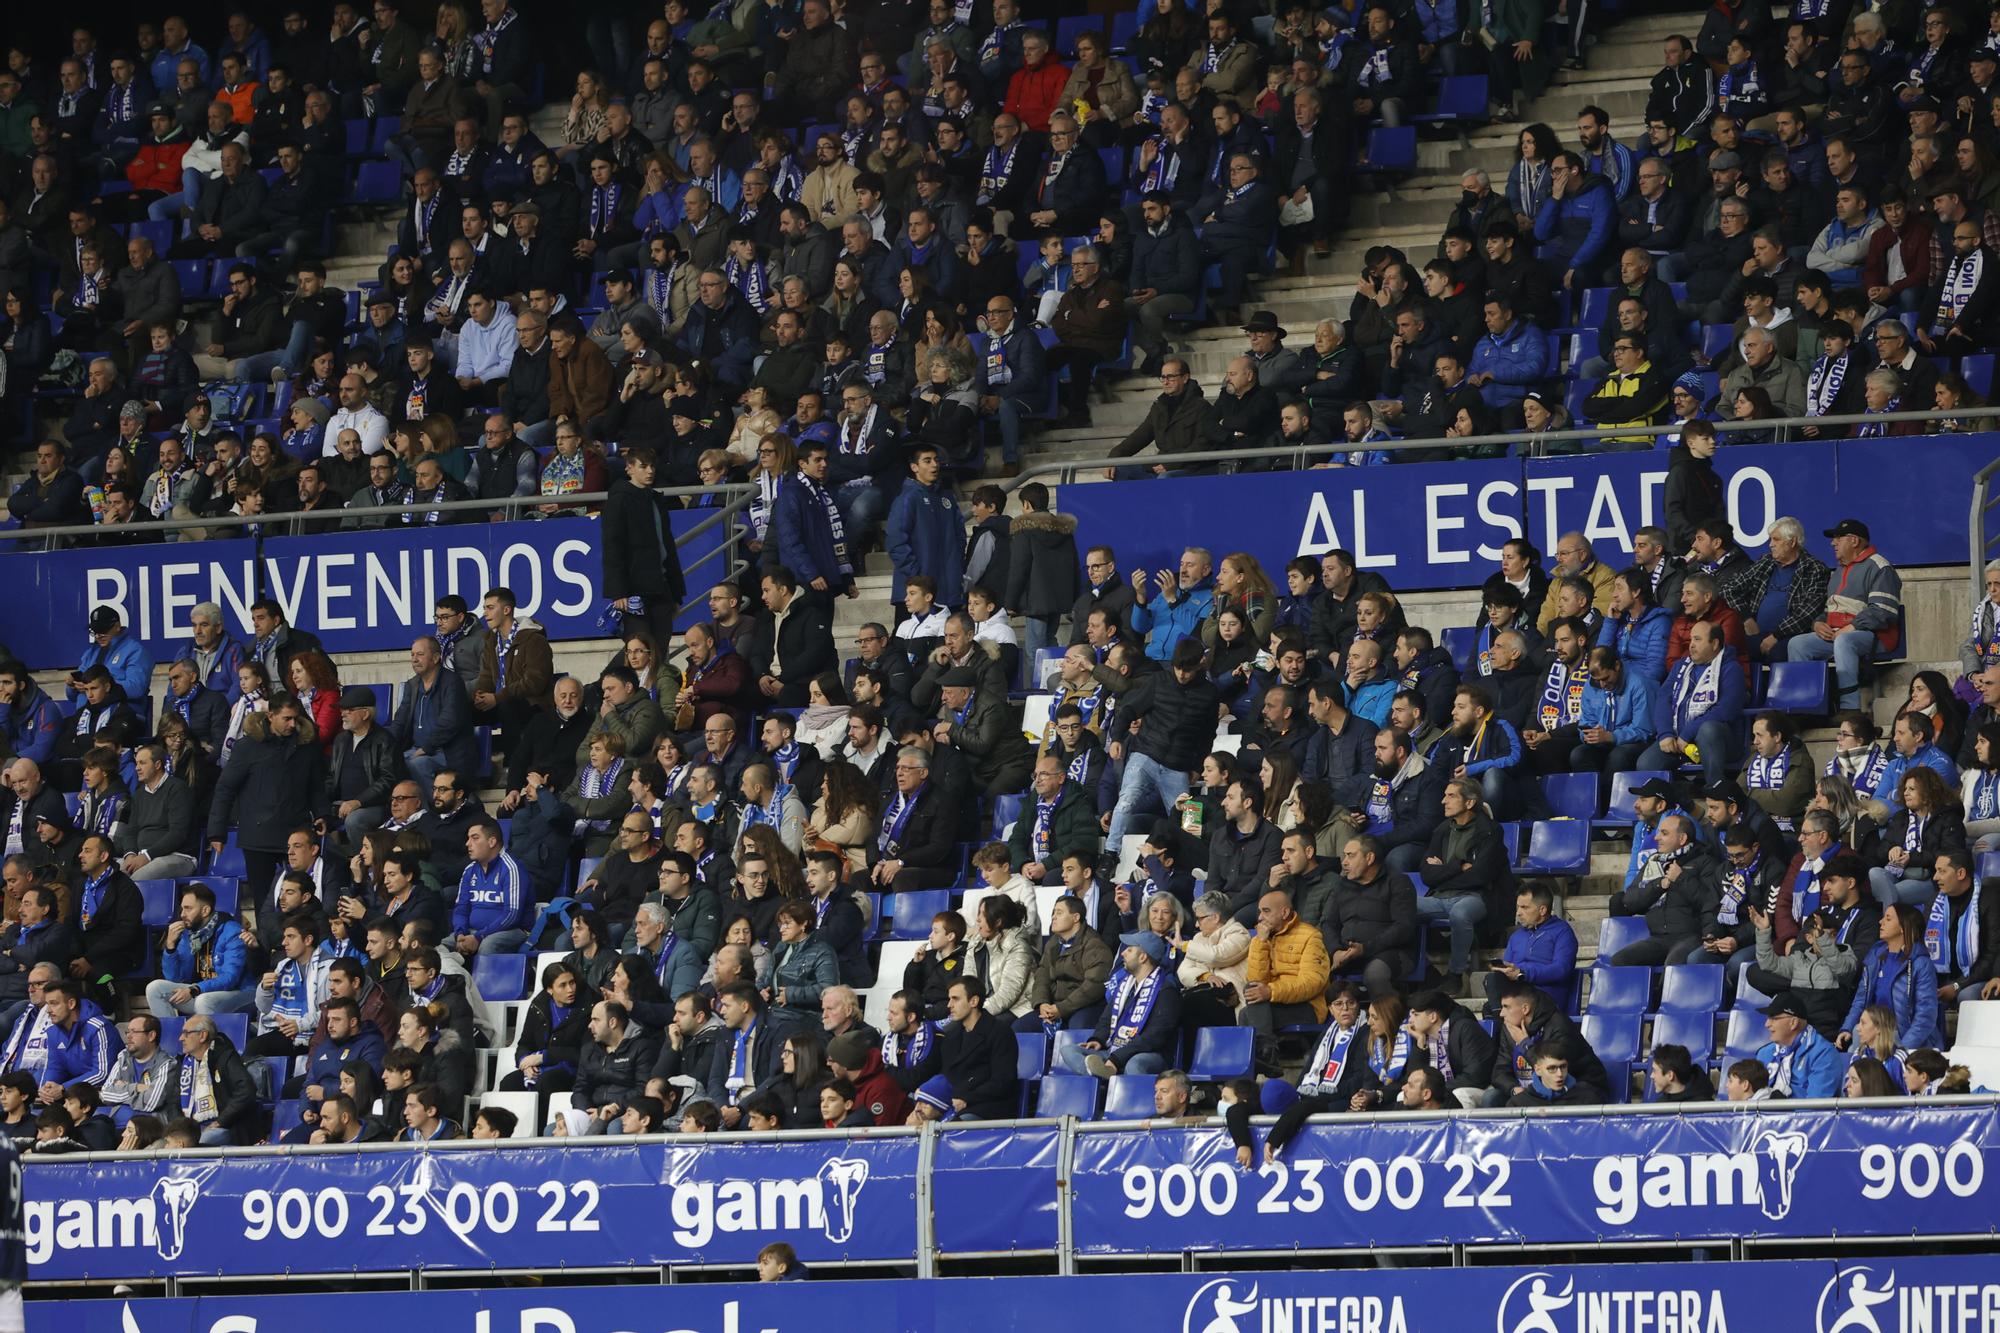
<box><xmin>930</xmin><ymin>1125</ymin><xmax>1062</xmax><ymax>1255</ymax></box>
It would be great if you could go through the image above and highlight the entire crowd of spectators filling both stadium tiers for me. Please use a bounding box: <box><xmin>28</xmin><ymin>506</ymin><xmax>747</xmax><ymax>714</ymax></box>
<box><xmin>0</xmin><ymin>0</ymin><xmax>2000</xmax><ymax>1153</ymax></box>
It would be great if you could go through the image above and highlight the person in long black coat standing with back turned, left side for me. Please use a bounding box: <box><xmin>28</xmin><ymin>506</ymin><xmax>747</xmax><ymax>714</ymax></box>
<box><xmin>208</xmin><ymin>699</ymin><xmax>326</xmax><ymax>889</ymax></box>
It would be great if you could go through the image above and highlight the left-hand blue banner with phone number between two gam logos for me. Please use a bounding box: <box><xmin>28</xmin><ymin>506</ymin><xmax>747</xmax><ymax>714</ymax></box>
<box><xmin>22</xmin><ymin>1133</ymin><xmax>918</xmax><ymax>1281</ymax></box>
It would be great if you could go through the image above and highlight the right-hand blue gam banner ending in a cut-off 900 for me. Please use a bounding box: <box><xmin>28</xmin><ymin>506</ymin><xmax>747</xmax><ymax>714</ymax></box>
<box><xmin>1070</xmin><ymin>1105</ymin><xmax>2000</xmax><ymax>1255</ymax></box>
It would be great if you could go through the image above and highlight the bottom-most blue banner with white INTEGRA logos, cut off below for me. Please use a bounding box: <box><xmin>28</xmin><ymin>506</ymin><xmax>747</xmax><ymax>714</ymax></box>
<box><xmin>50</xmin><ymin>1255</ymin><xmax>2000</xmax><ymax>1333</ymax></box>
